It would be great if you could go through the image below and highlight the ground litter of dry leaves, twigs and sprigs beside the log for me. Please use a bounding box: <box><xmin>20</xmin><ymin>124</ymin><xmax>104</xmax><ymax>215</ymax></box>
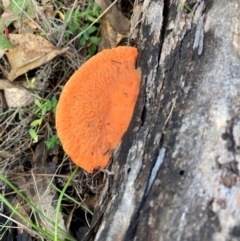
<box><xmin>0</xmin><ymin>0</ymin><xmax>136</xmax><ymax>240</ymax></box>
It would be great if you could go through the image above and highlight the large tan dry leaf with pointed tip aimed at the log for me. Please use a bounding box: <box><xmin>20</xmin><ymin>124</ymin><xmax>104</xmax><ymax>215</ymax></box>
<box><xmin>6</xmin><ymin>33</ymin><xmax>67</xmax><ymax>81</ymax></box>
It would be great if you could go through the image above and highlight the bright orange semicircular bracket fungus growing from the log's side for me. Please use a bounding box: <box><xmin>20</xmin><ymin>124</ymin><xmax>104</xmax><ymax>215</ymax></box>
<box><xmin>56</xmin><ymin>47</ymin><xmax>140</xmax><ymax>173</ymax></box>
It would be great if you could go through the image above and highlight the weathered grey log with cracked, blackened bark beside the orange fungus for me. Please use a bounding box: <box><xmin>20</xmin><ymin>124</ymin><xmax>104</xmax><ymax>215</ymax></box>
<box><xmin>85</xmin><ymin>0</ymin><xmax>240</xmax><ymax>241</ymax></box>
